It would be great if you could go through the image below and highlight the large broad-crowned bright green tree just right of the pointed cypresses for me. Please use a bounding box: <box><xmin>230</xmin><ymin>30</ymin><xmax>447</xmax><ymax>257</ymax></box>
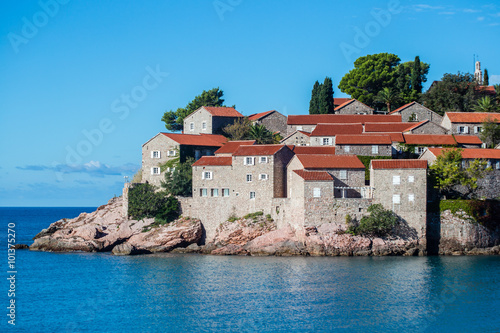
<box><xmin>338</xmin><ymin>53</ymin><xmax>401</xmax><ymax>106</ymax></box>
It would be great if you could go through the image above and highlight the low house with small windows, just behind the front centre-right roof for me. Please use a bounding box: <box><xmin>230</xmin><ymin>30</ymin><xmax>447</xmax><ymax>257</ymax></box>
<box><xmin>335</xmin><ymin>134</ymin><xmax>392</xmax><ymax>156</ymax></box>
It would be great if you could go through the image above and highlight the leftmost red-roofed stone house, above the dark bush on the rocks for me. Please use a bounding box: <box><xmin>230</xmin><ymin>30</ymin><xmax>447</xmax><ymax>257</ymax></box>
<box><xmin>142</xmin><ymin>133</ymin><xmax>227</xmax><ymax>186</ymax></box>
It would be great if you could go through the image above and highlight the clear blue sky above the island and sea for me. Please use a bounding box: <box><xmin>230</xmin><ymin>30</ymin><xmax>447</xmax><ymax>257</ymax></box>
<box><xmin>0</xmin><ymin>0</ymin><xmax>500</xmax><ymax>207</ymax></box>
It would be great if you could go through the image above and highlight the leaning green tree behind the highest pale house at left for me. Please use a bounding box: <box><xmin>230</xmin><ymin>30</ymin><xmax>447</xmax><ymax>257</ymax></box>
<box><xmin>161</xmin><ymin>88</ymin><xmax>224</xmax><ymax>132</ymax></box>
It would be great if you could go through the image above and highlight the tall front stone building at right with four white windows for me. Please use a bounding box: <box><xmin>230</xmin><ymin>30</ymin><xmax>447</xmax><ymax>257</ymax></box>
<box><xmin>370</xmin><ymin>160</ymin><xmax>427</xmax><ymax>238</ymax></box>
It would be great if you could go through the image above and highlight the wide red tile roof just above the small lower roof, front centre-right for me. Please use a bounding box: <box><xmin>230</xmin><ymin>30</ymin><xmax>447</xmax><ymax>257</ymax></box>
<box><xmin>295</xmin><ymin>154</ymin><xmax>365</xmax><ymax>169</ymax></box>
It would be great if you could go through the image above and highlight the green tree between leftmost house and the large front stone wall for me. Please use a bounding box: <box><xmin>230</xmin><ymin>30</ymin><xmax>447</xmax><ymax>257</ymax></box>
<box><xmin>161</xmin><ymin>157</ymin><xmax>195</xmax><ymax>197</ymax></box>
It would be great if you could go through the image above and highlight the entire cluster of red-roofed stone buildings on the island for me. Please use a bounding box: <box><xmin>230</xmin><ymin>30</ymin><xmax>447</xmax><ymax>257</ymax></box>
<box><xmin>142</xmin><ymin>99</ymin><xmax>500</xmax><ymax>238</ymax></box>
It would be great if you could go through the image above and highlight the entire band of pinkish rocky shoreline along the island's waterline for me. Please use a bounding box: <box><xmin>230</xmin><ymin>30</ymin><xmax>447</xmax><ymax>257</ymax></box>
<box><xmin>30</xmin><ymin>197</ymin><xmax>500</xmax><ymax>256</ymax></box>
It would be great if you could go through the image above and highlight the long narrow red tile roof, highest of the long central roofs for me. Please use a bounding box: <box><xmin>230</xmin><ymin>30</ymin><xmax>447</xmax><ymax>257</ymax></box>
<box><xmin>287</xmin><ymin>114</ymin><xmax>401</xmax><ymax>125</ymax></box>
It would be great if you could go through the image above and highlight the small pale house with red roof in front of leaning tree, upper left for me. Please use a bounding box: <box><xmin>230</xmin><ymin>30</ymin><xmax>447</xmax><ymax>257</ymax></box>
<box><xmin>184</xmin><ymin>106</ymin><xmax>243</xmax><ymax>134</ymax></box>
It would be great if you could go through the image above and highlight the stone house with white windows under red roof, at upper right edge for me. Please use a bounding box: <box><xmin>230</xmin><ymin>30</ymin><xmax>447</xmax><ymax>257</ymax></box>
<box><xmin>441</xmin><ymin>112</ymin><xmax>500</xmax><ymax>136</ymax></box>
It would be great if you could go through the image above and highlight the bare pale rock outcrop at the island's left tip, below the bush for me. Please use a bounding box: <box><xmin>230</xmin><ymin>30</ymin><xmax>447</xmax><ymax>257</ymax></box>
<box><xmin>30</xmin><ymin>198</ymin><xmax>203</xmax><ymax>255</ymax></box>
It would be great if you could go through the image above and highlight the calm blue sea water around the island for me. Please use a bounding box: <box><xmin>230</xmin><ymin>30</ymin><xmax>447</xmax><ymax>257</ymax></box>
<box><xmin>0</xmin><ymin>208</ymin><xmax>500</xmax><ymax>332</ymax></box>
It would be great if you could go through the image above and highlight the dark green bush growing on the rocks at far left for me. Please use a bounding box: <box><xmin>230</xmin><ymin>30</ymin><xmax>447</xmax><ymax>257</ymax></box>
<box><xmin>128</xmin><ymin>184</ymin><xmax>179</xmax><ymax>223</ymax></box>
